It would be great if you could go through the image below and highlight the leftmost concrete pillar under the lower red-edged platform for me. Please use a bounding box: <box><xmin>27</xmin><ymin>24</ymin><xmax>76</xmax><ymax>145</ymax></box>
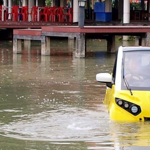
<box><xmin>13</xmin><ymin>39</ymin><xmax>22</xmax><ymax>54</ymax></box>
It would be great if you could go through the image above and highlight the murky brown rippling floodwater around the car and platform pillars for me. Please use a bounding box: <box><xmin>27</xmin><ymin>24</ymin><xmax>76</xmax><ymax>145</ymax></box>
<box><xmin>0</xmin><ymin>39</ymin><xmax>150</xmax><ymax>150</ymax></box>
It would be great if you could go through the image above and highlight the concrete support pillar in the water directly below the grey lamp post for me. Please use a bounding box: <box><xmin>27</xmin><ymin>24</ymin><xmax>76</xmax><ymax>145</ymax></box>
<box><xmin>75</xmin><ymin>33</ymin><xmax>86</xmax><ymax>58</ymax></box>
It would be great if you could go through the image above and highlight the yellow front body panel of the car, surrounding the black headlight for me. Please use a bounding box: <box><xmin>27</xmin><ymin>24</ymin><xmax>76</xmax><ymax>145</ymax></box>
<box><xmin>104</xmin><ymin>85</ymin><xmax>150</xmax><ymax>122</ymax></box>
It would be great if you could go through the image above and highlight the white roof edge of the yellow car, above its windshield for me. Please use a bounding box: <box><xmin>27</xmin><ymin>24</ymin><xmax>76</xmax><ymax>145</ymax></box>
<box><xmin>119</xmin><ymin>46</ymin><xmax>150</xmax><ymax>51</ymax></box>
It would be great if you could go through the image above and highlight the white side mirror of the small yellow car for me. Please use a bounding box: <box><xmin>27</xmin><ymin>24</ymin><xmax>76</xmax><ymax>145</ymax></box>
<box><xmin>96</xmin><ymin>73</ymin><xmax>112</xmax><ymax>88</ymax></box>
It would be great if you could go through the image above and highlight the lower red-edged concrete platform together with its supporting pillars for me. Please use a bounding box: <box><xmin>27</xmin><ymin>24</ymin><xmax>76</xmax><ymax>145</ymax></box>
<box><xmin>13</xmin><ymin>26</ymin><xmax>150</xmax><ymax>57</ymax></box>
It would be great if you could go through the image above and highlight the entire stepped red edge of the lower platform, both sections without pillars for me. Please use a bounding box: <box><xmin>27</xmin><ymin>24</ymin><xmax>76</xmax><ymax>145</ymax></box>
<box><xmin>13</xmin><ymin>26</ymin><xmax>150</xmax><ymax>36</ymax></box>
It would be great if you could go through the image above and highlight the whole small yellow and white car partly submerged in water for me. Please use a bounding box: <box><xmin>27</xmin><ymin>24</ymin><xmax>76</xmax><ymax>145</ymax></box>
<box><xmin>96</xmin><ymin>46</ymin><xmax>150</xmax><ymax>122</ymax></box>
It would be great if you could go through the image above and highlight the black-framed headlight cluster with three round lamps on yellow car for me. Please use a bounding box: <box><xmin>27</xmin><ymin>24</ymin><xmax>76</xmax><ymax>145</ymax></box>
<box><xmin>116</xmin><ymin>98</ymin><xmax>141</xmax><ymax>116</ymax></box>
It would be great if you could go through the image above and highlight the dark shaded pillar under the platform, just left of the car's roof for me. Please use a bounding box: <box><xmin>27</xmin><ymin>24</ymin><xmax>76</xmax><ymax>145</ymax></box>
<box><xmin>107</xmin><ymin>35</ymin><xmax>115</xmax><ymax>53</ymax></box>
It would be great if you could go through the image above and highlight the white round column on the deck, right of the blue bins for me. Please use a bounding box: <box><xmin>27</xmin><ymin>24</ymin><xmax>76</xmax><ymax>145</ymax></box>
<box><xmin>123</xmin><ymin>0</ymin><xmax>130</xmax><ymax>23</ymax></box>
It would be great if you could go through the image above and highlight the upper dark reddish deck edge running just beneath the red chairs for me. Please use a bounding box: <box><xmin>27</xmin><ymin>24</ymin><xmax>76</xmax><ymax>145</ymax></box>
<box><xmin>0</xmin><ymin>20</ymin><xmax>150</xmax><ymax>29</ymax></box>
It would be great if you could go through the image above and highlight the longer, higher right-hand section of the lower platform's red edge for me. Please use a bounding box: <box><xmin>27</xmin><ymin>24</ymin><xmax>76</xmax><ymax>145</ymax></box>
<box><xmin>42</xmin><ymin>26</ymin><xmax>150</xmax><ymax>34</ymax></box>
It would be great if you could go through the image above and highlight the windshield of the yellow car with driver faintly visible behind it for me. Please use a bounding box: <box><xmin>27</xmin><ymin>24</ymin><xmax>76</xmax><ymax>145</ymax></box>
<box><xmin>122</xmin><ymin>50</ymin><xmax>150</xmax><ymax>90</ymax></box>
